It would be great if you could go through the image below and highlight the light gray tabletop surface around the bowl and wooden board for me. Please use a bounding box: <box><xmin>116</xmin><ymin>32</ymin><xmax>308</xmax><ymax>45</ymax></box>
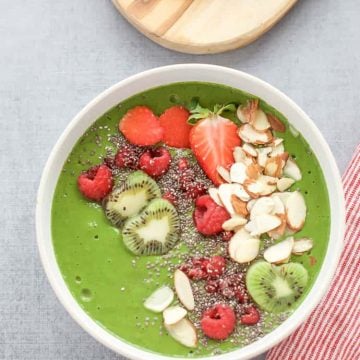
<box><xmin>0</xmin><ymin>0</ymin><xmax>360</xmax><ymax>360</ymax></box>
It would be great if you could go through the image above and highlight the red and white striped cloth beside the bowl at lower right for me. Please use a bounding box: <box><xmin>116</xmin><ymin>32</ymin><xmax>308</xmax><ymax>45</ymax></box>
<box><xmin>266</xmin><ymin>145</ymin><xmax>360</xmax><ymax>360</ymax></box>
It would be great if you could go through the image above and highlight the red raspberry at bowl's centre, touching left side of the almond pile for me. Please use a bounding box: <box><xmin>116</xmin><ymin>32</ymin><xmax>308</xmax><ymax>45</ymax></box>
<box><xmin>193</xmin><ymin>195</ymin><xmax>230</xmax><ymax>235</ymax></box>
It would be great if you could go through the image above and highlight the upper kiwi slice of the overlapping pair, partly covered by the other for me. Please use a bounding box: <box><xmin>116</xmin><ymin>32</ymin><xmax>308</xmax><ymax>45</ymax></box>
<box><xmin>103</xmin><ymin>171</ymin><xmax>161</xmax><ymax>226</ymax></box>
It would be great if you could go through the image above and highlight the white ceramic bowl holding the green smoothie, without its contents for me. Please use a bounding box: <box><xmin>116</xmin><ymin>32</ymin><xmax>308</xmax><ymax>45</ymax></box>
<box><xmin>36</xmin><ymin>64</ymin><xmax>345</xmax><ymax>360</ymax></box>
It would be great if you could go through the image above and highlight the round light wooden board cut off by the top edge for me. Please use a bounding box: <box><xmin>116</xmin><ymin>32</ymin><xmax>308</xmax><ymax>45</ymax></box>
<box><xmin>113</xmin><ymin>0</ymin><xmax>297</xmax><ymax>54</ymax></box>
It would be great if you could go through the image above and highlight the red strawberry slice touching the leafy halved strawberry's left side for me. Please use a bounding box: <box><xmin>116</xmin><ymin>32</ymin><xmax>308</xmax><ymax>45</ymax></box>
<box><xmin>159</xmin><ymin>106</ymin><xmax>191</xmax><ymax>148</ymax></box>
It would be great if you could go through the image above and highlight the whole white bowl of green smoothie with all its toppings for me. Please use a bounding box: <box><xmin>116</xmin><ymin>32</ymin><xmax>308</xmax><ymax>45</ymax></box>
<box><xmin>37</xmin><ymin>65</ymin><xmax>344</xmax><ymax>359</ymax></box>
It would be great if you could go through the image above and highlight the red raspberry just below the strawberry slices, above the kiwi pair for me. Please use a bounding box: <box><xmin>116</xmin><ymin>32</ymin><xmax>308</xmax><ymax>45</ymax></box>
<box><xmin>139</xmin><ymin>147</ymin><xmax>171</xmax><ymax>177</ymax></box>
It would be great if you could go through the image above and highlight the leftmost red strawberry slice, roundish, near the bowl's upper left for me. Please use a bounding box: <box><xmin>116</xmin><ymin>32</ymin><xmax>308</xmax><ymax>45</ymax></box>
<box><xmin>119</xmin><ymin>106</ymin><xmax>164</xmax><ymax>146</ymax></box>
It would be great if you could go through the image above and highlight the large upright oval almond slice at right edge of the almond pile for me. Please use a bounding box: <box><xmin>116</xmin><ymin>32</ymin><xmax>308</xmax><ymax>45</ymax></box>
<box><xmin>285</xmin><ymin>191</ymin><xmax>306</xmax><ymax>231</ymax></box>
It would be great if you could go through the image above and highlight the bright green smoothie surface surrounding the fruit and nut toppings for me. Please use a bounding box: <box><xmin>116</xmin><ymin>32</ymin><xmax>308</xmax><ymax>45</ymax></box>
<box><xmin>52</xmin><ymin>82</ymin><xmax>330</xmax><ymax>357</ymax></box>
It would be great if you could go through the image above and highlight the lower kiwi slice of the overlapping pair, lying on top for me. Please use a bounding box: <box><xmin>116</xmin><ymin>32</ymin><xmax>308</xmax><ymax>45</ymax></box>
<box><xmin>122</xmin><ymin>199</ymin><xmax>180</xmax><ymax>255</ymax></box>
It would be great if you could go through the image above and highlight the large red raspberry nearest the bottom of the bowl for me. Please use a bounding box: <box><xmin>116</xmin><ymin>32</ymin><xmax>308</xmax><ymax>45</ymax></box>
<box><xmin>200</xmin><ymin>304</ymin><xmax>236</xmax><ymax>340</ymax></box>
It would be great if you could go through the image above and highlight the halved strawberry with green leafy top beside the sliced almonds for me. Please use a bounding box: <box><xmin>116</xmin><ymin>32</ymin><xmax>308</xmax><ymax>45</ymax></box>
<box><xmin>189</xmin><ymin>102</ymin><xmax>241</xmax><ymax>185</ymax></box>
